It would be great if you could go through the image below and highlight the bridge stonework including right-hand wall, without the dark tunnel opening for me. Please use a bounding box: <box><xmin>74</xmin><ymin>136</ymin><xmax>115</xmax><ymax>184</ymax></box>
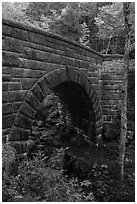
<box><xmin>2</xmin><ymin>20</ymin><xmax>135</xmax><ymax>153</ymax></box>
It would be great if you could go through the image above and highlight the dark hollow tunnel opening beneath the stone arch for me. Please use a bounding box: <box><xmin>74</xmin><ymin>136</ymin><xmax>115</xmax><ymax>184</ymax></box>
<box><xmin>53</xmin><ymin>81</ymin><xmax>96</xmax><ymax>140</ymax></box>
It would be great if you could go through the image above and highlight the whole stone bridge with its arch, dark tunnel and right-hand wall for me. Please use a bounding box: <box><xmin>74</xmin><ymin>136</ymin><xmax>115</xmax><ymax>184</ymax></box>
<box><xmin>2</xmin><ymin>19</ymin><xmax>127</xmax><ymax>152</ymax></box>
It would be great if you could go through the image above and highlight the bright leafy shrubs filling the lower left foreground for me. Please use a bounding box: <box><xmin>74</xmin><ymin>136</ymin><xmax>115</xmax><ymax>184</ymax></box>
<box><xmin>3</xmin><ymin>144</ymin><xmax>93</xmax><ymax>202</ymax></box>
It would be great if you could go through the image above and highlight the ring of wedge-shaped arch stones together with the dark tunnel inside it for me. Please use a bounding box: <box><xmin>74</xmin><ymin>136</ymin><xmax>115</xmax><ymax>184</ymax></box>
<box><xmin>8</xmin><ymin>67</ymin><xmax>102</xmax><ymax>153</ymax></box>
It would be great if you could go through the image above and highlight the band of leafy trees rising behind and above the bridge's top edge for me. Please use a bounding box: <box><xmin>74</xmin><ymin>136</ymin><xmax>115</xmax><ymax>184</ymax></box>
<box><xmin>2</xmin><ymin>2</ymin><xmax>135</xmax><ymax>55</ymax></box>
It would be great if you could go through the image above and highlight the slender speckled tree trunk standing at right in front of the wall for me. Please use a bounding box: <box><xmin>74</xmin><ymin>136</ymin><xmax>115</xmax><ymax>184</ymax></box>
<box><xmin>119</xmin><ymin>2</ymin><xmax>131</xmax><ymax>180</ymax></box>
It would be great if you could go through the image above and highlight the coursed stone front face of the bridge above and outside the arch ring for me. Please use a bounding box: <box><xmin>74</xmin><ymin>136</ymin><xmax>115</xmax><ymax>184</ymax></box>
<box><xmin>2</xmin><ymin>19</ymin><xmax>103</xmax><ymax>142</ymax></box>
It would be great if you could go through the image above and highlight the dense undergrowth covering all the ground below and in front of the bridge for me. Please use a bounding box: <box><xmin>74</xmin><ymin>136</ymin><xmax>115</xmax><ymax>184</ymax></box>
<box><xmin>2</xmin><ymin>93</ymin><xmax>134</xmax><ymax>202</ymax></box>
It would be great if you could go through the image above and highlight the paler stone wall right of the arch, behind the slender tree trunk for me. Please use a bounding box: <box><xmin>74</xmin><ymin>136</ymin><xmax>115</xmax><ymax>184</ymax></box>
<box><xmin>100</xmin><ymin>59</ymin><xmax>135</xmax><ymax>126</ymax></box>
